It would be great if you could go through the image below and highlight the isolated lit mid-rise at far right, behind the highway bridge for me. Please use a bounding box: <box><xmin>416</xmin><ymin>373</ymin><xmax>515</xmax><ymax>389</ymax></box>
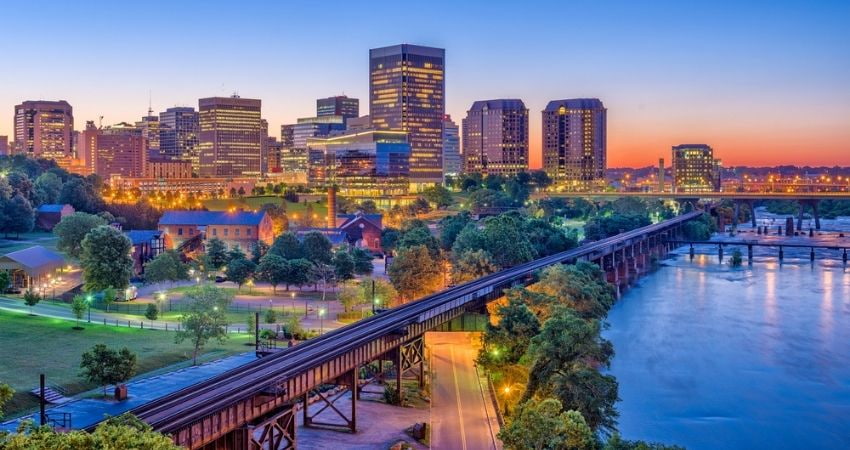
<box><xmin>672</xmin><ymin>144</ymin><xmax>720</xmax><ymax>192</ymax></box>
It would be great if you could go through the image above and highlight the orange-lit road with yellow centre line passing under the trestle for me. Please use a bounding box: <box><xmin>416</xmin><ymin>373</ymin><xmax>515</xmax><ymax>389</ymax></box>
<box><xmin>425</xmin><ymin>332</ymin><xmax>501</xmax><ymax>450</ymax></box>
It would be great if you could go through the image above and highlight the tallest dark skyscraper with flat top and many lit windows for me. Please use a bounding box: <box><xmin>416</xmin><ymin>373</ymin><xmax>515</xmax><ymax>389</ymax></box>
<box><xmin>369</xmin><ymin>44</ymin><xmax>446</xmax><ymax>189</ymax></box>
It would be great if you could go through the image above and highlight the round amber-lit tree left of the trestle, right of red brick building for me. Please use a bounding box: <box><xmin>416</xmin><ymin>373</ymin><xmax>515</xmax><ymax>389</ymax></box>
<box><xmin>387</xmin><ymin>245</ymin><xmax>442</xmax><ymax>300</ymax></box>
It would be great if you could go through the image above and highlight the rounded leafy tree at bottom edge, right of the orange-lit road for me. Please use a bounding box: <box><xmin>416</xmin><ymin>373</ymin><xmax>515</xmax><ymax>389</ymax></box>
<box><xmin>498</xmin><ymin>398</ymin><xmax>597</xmax><ymax>450</ymax></box>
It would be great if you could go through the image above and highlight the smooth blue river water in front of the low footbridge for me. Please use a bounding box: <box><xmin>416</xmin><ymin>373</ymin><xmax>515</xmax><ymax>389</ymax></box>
<box><xmin>605</xmin><ymin>250</ymin><xmax>850</xmax><ymax>449</ymax></box>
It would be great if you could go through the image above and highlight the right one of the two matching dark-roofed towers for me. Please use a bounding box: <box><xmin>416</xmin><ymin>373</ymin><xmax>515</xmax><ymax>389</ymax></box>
<box><xmin>543</xmin><ymin>98</ymin><xmax>607</xmax><ymax>189</ymax></box>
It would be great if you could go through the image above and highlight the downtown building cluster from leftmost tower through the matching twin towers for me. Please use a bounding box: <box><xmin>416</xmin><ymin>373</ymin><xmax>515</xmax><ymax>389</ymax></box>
<box><xmin>0</xmin><ymin>44</ymin><xmax>636</xmax><ymax>199</ymax></box>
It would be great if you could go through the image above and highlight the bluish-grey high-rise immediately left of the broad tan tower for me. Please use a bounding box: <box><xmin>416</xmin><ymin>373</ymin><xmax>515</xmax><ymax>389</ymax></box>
<box><xmin>159</xmin><ymin>107</ymin><xmax>200</xmax><ymax>173</ymax></box>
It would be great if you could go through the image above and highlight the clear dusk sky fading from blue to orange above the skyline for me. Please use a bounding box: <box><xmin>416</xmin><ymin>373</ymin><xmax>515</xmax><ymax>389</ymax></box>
<box><xmin>0</xmin><ymin>0</ymin><xmax>850</xmax><ymax>167</ymax></box>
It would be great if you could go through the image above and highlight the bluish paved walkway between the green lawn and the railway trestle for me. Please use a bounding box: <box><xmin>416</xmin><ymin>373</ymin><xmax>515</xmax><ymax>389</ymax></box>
<box><xmin>0</xmin><ymin>352</ymin><xmax>257</xmax><ymax>431</ymax></box>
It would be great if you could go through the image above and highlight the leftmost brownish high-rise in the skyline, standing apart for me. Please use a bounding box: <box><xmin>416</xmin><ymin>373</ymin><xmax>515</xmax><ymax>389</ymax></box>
<box><xmin>14</xmin><ymin>100</ymin><xmax>74</xmax><ymax>162</ymax></box>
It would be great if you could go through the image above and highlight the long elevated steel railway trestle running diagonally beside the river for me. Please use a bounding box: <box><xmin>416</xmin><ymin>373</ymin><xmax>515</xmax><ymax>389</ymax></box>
<box><xmin>93</xmin><ymin>212</ymin><xmax>701</xmax><ymax>449</ymax></box>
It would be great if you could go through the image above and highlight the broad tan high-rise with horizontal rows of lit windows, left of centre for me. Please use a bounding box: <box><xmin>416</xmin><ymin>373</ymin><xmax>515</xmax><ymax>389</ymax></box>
<box><xmin>198</xmin><ymin>96</ymin><xmax>266</xmax><ymax>177</ymax></box>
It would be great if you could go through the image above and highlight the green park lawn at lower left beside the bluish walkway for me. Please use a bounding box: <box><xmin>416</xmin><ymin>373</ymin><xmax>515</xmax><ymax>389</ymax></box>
<box><xmin>0</xmin><ymin>311</ymin><xmax>250</xmax><ymax>417</ymax></box>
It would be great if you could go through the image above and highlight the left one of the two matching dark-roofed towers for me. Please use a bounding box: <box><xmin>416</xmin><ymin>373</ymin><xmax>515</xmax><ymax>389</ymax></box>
<box><xmin>463</xmin><ymin>99</ymin><xmax>528</xmax><ymax>175</ymax></box>
